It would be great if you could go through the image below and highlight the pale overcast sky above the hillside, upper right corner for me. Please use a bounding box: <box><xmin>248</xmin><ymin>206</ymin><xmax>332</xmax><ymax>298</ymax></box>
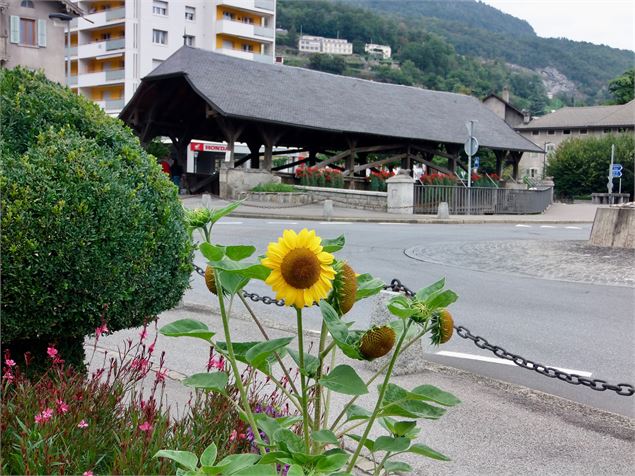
<box><xmin>481</xmin><ymin>0</ymin><xmax>635</xmax><ymax>50</ymax></box>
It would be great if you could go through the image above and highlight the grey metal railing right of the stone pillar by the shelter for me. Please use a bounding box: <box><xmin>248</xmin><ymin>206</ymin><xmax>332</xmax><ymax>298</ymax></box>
<box><xmin>414</xmin><ymin>184</ymin><xmax>552</xmax><ymax>215</ymax></box>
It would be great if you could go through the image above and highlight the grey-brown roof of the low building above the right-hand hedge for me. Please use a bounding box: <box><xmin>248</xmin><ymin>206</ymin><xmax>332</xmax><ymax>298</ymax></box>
<box><xmin>517</xmin><ymin>100</ymin><xmax>635</xmax><ymax>129</ymax></box>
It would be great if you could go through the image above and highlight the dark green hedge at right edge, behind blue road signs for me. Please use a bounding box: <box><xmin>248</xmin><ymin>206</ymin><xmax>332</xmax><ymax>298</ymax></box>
<box><xmin>547</xmin><ymin>133</ymin><xmax>635</xmax><ymax>197</ymax></box>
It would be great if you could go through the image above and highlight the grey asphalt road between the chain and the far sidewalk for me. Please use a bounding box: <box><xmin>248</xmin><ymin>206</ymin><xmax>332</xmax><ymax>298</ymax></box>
<box><xmin>185</xmin><ymin>217</ymin><xmax>635</xmax><ymax>417</ymax></box>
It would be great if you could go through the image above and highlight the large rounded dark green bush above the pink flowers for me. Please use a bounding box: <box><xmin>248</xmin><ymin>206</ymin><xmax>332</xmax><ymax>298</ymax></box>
<box><xmin>0</xmin><ymin>68</ymin><xmax>191</xmax><ymax>354</ymax></box>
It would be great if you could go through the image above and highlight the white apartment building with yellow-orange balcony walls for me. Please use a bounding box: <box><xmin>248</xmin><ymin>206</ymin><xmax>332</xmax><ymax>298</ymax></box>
<box><xmin>70</xmin><ymin>0</ymin><xmax>276</xmax><ymax>115</ymax></box>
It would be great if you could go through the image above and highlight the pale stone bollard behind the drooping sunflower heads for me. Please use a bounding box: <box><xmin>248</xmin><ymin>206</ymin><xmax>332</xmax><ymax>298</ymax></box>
<box><xmin>366</xmin><ymin>291</ymin><xmax>428</xmax><ymax>375</ymax></box>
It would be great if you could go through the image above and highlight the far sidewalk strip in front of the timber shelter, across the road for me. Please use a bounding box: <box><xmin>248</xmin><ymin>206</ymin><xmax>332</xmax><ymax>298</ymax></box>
<box><xmin>181</xmin><ymin>195</ymin><xmax>598</xmax><ymax>224</ymax></box>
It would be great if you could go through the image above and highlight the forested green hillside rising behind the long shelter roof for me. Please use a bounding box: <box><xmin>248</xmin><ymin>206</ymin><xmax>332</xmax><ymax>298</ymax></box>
<box><xmin>277</xmin><ymin>0</ymin><xmax>635</xmax><ymax>109</ymax></box>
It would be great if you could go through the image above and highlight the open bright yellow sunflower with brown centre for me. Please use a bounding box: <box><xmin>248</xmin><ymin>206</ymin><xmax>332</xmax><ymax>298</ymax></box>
<box><xmin>262</xmin><ymin>228</ymin><xmax>335</xmax><ymax>308</ymax></box>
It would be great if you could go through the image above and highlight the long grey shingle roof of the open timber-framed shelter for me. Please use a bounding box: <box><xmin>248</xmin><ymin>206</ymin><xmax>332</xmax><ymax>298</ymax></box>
<box><xmin>144</xmin><ymin>46</ymin><xmax>541</xmax><ymax>151</ymax></box>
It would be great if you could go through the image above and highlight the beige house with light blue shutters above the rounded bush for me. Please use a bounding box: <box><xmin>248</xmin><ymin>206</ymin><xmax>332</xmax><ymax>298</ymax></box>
<box><xmin>0</xmin><ymin>0</ymin><xmax>82</xmax><ymax>84</ymax></box>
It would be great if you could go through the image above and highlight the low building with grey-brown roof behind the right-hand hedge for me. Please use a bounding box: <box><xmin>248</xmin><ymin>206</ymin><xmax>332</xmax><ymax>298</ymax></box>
<box><xmin>513</xmin><ymin>100</ymin><xmax>635</xmax><ymax>177</ymax></box>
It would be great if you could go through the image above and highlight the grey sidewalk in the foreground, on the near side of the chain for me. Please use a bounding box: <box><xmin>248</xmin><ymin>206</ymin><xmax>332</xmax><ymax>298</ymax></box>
<box><xmin>93</xmin><ymin>304</ymin><xmax>635</xmax><ymax>476</ymax></box>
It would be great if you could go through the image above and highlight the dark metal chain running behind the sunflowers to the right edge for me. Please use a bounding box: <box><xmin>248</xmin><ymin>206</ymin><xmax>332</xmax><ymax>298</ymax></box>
<box><xmin>194</xmin><ymin>265</ymin><xmax>635</xmax><ymax>397</ymax></box>
